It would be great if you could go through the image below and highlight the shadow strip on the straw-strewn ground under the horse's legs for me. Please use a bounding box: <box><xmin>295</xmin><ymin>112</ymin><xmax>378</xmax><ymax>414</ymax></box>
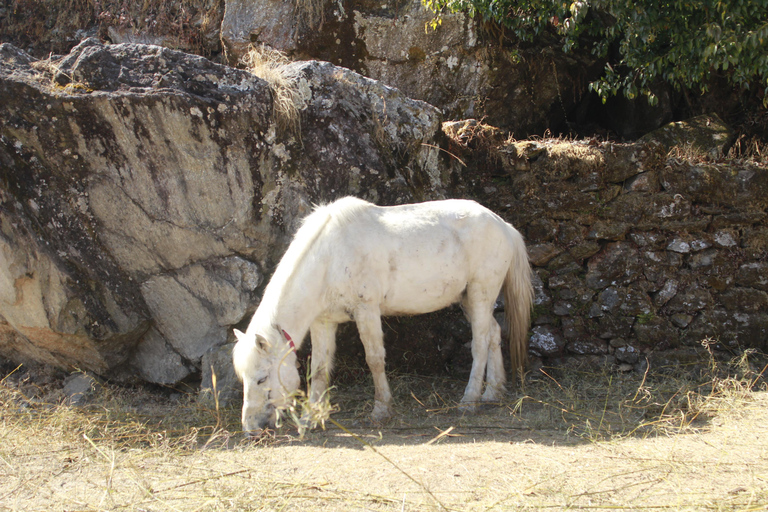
<box><xmin>240</xmin><ymin>358</ymin><xmax>711</xmax><ymax>449</ymax></box>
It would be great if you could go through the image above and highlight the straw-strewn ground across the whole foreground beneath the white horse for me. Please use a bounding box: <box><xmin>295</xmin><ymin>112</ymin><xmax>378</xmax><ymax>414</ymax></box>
<box><xmin>0</xmin><ymin>352</ymin><xmax>768</xmax><ymax>511</ymax></box>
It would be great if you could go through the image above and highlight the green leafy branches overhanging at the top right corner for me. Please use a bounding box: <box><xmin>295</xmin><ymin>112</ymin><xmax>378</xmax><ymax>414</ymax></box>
<box><xmin>423</xmin><ymin>0</ymin><xmax>768</xmax><ymax>106</ymax></box>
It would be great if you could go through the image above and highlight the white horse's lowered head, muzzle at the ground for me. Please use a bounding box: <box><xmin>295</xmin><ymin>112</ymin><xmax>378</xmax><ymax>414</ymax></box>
<box><xmin>232</xmin><ymin>329</ymin><xmax>301</xmax><ymax>437</ymax></box>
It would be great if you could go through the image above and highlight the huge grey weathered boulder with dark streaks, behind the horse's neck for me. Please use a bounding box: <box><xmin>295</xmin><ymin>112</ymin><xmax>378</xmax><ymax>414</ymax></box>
<box><xmin>0</xmin><ymin>40</ymin><xmax>448</xmax><ymax>383</ymax></box>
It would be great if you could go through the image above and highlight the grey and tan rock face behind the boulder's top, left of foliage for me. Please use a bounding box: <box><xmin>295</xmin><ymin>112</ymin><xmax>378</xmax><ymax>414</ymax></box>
<box><xmin>221</xmin><ymin>0</ymin><xmax>604</xmax><ymax>136</ymax></box>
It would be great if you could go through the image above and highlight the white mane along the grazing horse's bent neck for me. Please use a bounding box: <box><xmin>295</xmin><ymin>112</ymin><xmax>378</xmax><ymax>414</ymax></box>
<box><xmin>252</xmin><ymin>197</ymin><xmax>373</xmax><ymax>332</ymax></box>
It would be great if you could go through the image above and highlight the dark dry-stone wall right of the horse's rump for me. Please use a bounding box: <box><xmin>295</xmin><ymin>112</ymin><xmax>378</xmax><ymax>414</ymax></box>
<box><xmin>456</xmin><ymin>127</ymin><xmax>768</xmax><ymax>370</ymax></box>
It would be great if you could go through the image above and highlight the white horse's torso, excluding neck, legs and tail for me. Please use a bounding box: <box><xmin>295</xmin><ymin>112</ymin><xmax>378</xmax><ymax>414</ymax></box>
<box><xmin>316</xmin><ymin>199</ymin><xmax>512</xmax><ymax>314</ymax></box>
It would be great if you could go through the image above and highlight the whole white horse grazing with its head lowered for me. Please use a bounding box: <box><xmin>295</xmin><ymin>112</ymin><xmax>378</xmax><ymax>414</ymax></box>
<box><xmin>233</xmin><ymin>197</ymin><xmax>533</xmax><ymax>436</ymax></box>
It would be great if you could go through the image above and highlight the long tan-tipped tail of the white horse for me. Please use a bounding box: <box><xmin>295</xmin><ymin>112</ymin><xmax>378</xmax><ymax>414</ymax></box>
<box><xmin>504</xmin><ymin>226</ymin><xmax>533</xmax><ymax>384</ymax></box>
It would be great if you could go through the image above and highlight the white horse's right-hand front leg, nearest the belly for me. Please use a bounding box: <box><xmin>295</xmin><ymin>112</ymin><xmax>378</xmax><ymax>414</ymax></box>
<box><xmin>355</xmin><ymin>305</ymin><xmax>392</xmax><ymax>423</ymax></box>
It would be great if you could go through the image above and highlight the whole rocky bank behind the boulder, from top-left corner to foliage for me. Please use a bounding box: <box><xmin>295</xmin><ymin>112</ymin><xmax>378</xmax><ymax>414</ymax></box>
<box><xmin>0</xmin><ymin>0</ymin><xmax>674</xmax><ymax>139</ymax></box>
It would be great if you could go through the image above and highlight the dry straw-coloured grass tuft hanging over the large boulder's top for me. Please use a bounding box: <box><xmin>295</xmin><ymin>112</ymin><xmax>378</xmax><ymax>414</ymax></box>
<box><xmin>241</xmin><ymin>45</ymin><xmax>301</xmax><ymax>138</ymax></box>
